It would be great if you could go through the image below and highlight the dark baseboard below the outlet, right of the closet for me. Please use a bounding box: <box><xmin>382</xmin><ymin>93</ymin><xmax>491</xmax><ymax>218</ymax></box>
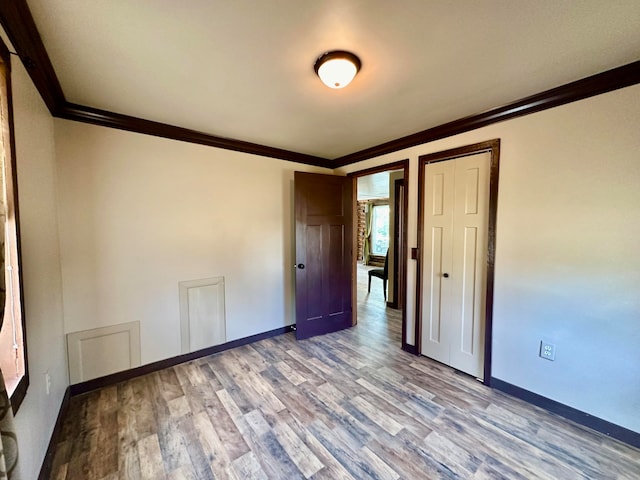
<box><xmin>491</xmin><ymin>377</ymin><xmax>640</xmax><ymax>448</ymax></box>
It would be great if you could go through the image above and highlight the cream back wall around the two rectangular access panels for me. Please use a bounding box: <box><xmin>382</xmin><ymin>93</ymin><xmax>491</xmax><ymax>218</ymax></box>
<box><xmin>55</xmin><ymin>120</ymin><xmax>329</xmax><ymax>364</ymax></box>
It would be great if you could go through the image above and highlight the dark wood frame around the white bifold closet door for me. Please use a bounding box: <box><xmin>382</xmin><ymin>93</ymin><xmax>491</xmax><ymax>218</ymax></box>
<box><xmin>415</xmin><ymin>138</ymin><xmax>500</xmax><ymax>386</ymax></box>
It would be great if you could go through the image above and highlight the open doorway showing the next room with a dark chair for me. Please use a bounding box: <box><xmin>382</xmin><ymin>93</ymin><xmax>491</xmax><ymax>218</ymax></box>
<box><xmin>350</xmin><ymin>161</ymin><xmax>408</xmax><ymax>349</ymax></box>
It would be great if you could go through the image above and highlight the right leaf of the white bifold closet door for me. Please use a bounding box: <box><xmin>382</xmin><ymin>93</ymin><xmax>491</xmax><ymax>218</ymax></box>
<box><xmin>449</xmin><ymin>152</ymin><xmax>491</xmax><ymax>378</ymax></box>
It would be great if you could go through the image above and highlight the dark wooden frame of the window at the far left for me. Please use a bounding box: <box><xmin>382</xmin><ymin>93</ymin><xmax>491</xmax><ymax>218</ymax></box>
<box><xmin>0</xmin><ymin>39</ymin><xmax>29</xmax><ymax>415</ymax></box>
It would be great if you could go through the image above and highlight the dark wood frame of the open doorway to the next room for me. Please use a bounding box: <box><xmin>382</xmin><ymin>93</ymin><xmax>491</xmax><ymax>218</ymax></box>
<box><xmin>347</xmin><ymin>158</ymin><xmax>408</xmax><ymax>353</ymax></box>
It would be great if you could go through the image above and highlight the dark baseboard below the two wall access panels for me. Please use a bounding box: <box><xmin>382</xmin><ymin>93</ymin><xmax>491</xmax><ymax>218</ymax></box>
<box><xmin>69</xmin><ymin>325</ymin><xmax>295</xmax><ymax>396</ymax></box>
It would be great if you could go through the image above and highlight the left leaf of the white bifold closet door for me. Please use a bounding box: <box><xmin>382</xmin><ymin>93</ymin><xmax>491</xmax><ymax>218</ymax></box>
<box><xmin>421</xmin><ymin>162</ymin><xmax>454</xmax><ymax>363</ymax></box>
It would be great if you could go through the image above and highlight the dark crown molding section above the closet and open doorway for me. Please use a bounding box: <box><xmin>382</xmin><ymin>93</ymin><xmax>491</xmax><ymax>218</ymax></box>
<box><xmin>333</xmin><ymin>61</ymin><xmax>640</xmax><ymax>168</ymax></box>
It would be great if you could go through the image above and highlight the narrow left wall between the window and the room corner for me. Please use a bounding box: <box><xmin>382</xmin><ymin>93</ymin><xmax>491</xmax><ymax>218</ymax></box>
<box><xmin>11</xmin><ymin>44</ymin><xmax>68</xmax><ymax>479</ymax></box>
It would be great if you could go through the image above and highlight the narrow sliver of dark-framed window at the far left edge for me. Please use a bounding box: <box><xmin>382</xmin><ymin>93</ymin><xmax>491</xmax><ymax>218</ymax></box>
<box><xmin>0</xmin><ymin>41</ymin><xmax>29</xmax><ymax>413</ymax></box>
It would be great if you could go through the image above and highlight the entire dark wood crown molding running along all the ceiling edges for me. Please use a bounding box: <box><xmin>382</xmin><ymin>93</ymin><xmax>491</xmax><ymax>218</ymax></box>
<box><xmin>0</xmin><ymin>0</ymin><xmax>640</xmax><ymax>168</ymax></box>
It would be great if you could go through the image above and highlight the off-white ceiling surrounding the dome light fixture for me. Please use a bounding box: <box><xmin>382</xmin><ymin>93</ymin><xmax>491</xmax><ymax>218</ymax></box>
<box><xmin>28</xmin><ymin>0</ymin><xmax>640</xmax><ymax>158</ymax></box>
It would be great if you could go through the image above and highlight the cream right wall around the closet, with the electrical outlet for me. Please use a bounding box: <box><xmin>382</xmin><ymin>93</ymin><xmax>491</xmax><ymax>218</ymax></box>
<box><xmin>339</xmin><ymin>85</ymin><xmax>640</xmax><ymax>432</ymax></box>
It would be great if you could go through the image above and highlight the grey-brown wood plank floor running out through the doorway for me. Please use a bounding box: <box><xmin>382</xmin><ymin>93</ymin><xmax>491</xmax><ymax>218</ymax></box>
<box><xmin>52</xmin><ymin>264</ymin><xmax>640</xmax><ymax>480</ymax></box>
